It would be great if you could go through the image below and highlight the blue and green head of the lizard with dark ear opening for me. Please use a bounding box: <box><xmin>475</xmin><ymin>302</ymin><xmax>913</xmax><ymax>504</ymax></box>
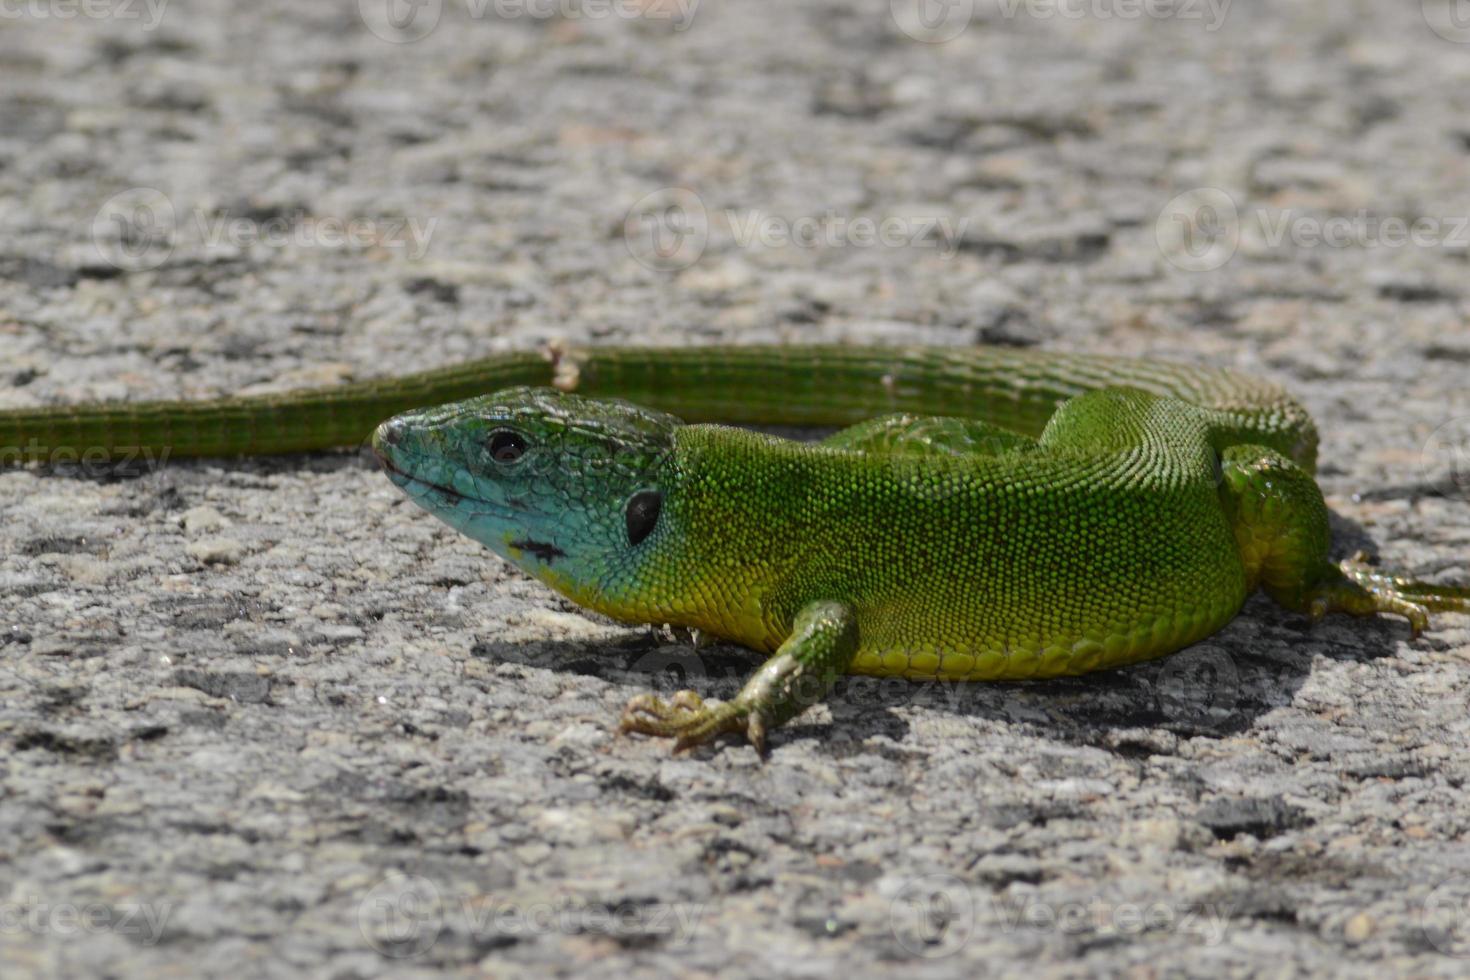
<box><xmin>372</xmin><ymin>388</ymin><xmax>681</xmax><ymax>607</ymax></box>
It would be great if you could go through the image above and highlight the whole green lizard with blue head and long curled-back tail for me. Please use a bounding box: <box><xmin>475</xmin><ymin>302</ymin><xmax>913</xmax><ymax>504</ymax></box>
<box><xmin>0</xmin><ymin>347</ymin><xmax>1470</xmax><ymax>751</ymax></box>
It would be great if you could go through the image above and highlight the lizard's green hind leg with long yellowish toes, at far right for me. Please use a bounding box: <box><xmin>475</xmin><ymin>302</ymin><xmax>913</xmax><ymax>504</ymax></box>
<box><xmin>1220</xmin><ymin>445</ymin><xmax>1470</xmax><ymax>636</ymax></box>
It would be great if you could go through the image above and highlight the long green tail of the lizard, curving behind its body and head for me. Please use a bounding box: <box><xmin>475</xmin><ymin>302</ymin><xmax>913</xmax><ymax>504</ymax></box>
<box><xmin>0</xmin><ymin>347</ymin><xmax>1317</xmax><ymax>470</ymax></box>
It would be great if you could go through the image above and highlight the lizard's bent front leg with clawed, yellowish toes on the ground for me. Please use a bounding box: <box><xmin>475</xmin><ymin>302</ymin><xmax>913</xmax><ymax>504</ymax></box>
<box><xmin>620</xmin><ymin>602</ymin><xmax>857</xmax><ymax>755</ymax></box>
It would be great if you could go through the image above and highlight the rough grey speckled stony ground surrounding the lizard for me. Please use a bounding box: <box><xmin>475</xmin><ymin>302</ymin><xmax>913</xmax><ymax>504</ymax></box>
<box><xmin>0</xmin><ymin>0</ymin><xmax>1470</xmax><ymax>979</ymax></box>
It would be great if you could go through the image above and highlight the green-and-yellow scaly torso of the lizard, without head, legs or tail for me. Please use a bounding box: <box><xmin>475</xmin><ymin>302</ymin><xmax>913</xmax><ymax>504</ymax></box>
<box><xmin>573</xmin><ymin>392</ymin><xmax>1248</xmax><ymax>680</ymax></box>
